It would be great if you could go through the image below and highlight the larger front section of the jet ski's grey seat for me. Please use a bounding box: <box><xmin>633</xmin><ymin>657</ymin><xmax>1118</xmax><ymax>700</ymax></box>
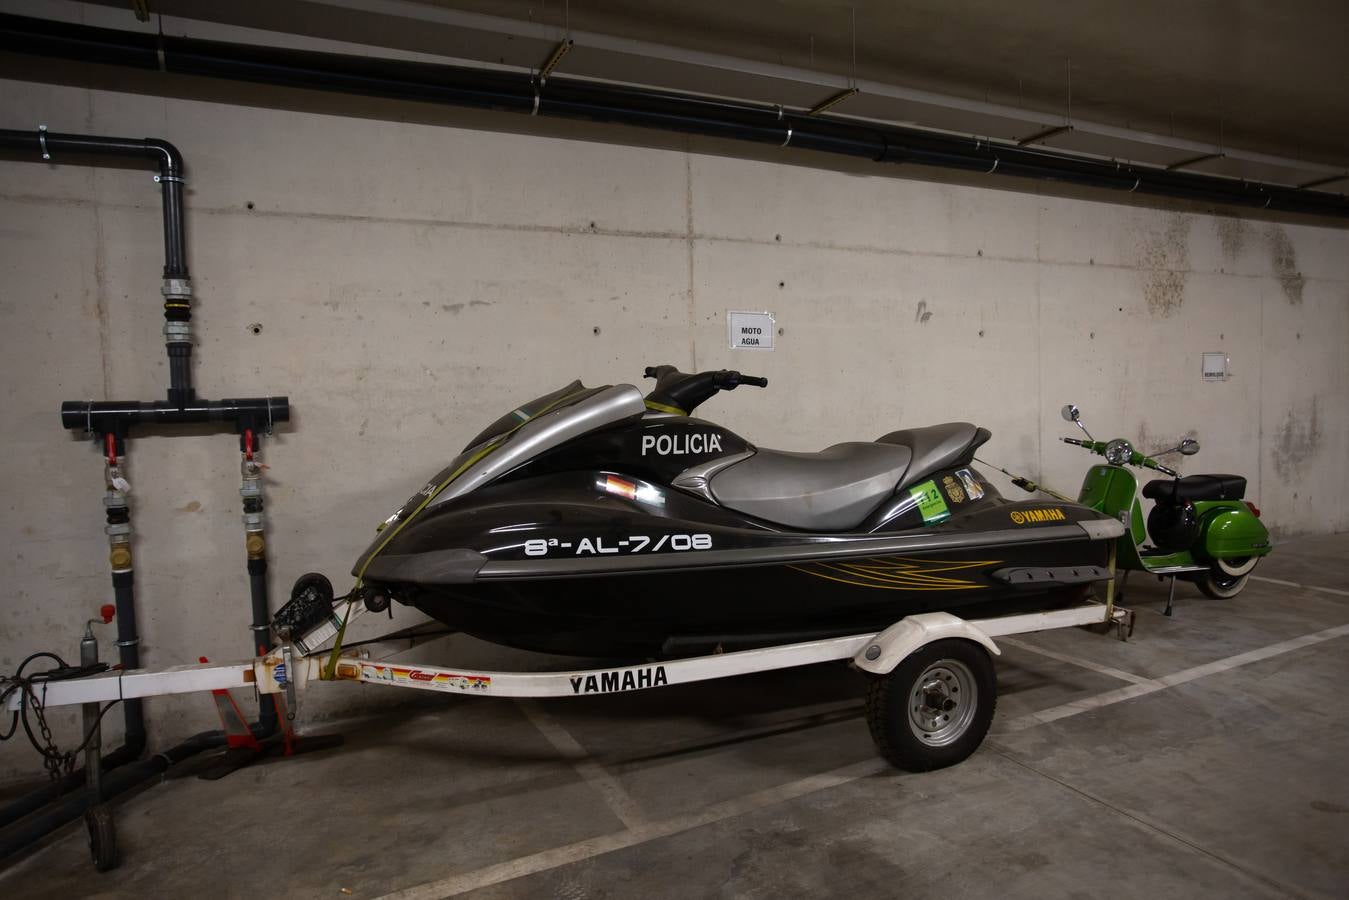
<box><xmin>708</xmin><ymin>443</ymin><xmax>912</xmax><ymax>532</ymax></box>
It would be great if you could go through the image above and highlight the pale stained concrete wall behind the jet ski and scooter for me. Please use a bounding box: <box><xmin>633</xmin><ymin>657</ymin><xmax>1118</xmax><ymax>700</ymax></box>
<box><xmin>0</xmin><ymin>81</ymin><xmax>1349</xmax><ymax>776</ymax></box>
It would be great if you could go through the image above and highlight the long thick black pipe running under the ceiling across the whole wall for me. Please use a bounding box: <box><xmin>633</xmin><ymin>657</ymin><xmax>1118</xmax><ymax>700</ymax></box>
<box><xmin>0</xmin><ymin>15</ymin><xmax>1349</xmax><ymax>217</ymax></box>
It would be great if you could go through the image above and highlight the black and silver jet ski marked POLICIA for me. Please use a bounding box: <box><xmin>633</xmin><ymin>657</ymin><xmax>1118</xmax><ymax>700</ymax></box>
<box><xmin>353</xmin><ymin>366</ymin><xmax>1124</xmax><ymax>656</ymax></box>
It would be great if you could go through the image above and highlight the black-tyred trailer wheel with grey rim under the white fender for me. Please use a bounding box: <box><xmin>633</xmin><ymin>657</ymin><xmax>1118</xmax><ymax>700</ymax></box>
<box><xmin>866</xmin><ymin>638</ymin><xmax>997</xmax><ymax>772</ymax></box>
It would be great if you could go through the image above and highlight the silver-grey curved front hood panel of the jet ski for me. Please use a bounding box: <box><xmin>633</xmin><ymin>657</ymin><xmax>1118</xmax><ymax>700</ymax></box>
<box><xmin>351</xmin><ymin>382</ymin><xmax>646</xmax><ymax>579</ymax></box>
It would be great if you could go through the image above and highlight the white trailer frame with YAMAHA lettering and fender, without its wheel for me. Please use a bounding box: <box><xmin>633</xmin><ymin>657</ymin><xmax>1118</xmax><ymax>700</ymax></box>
<box><xmin>8</xmin><ymin>602</ymin><xmax>1133</xmax><ymax>755</ymax></box>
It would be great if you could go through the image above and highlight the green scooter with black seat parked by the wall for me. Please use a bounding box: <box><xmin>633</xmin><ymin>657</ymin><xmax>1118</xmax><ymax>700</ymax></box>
<box><xmin>1062</xmin><ymin>403</ymin><xmax>1272</xmax><ymax>615</ymax></box>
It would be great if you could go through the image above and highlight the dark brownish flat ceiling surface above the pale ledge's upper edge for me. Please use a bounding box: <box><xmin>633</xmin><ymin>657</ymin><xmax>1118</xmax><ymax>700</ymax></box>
<box><xmin>429</xmin><ymin>0</ymin><xmax>1349</xmax><ymax>165</ymax></box>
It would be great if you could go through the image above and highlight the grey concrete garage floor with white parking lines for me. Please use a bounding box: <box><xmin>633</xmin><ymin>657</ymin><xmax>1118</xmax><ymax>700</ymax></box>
<box><xmin>0</xmin><ymin>534</ymin><xmax>1349</xmax><ymax>900</ymax></box>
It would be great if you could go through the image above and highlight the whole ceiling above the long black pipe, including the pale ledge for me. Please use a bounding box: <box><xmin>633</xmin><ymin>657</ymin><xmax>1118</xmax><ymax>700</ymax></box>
<box><xmin>36</xmin><ymin>0</ymin><xmax>1349</xmax><ymax>192</ymax></box>
